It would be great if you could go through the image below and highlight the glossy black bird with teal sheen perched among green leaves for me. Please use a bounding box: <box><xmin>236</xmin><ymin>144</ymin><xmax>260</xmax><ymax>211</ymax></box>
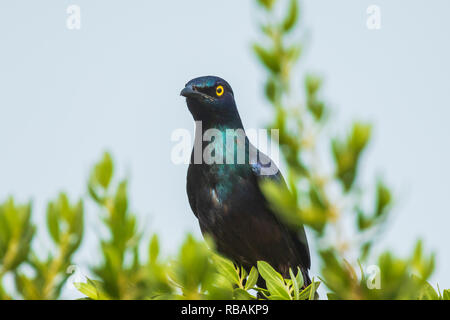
<box><xmin>180</xmin><ymin>76</ymin><xmax>311</xmax><ymax>287</ymax></box>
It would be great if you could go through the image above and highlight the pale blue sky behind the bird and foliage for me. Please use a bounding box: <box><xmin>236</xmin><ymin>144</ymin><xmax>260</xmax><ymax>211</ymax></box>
<box><xmin>0</xmin><ymin>0</ymin><xmax>450</xmax><ymax>298</ymax></box>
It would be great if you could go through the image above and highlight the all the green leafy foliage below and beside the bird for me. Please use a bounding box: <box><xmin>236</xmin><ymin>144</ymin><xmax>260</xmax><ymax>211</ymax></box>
<box><xmin>0</xmin><ymin>0</ymin><xmax>450</xmax><ymax>300</ymax></box>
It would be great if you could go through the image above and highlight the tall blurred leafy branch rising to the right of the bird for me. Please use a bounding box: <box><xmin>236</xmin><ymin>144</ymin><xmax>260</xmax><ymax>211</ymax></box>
<box><xmin>253</xmin><ymin>0</ymin><xmax>447</xmax><ymax>299</ymax></box>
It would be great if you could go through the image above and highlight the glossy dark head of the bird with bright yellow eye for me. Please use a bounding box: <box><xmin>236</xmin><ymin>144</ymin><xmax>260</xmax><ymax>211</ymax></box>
<box><xmin>180</xmin><ymin>76</ymin><xmax>240</xmax><ymax>124</ymax></box>
